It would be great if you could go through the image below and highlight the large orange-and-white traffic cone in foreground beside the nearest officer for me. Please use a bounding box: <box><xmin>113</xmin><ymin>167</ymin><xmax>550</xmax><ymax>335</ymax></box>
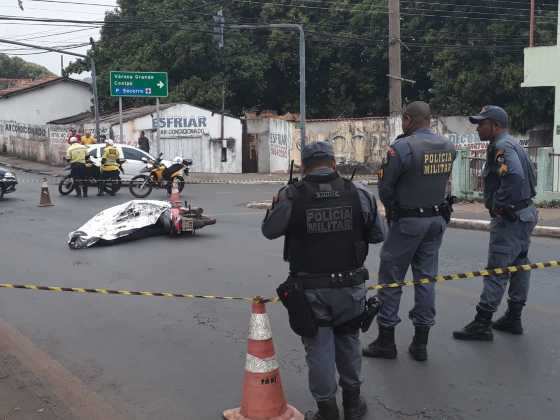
<box><xmin>223</xmin><ymin>302</ymin><xmax>303</xmax><ymax>420</ymax></box>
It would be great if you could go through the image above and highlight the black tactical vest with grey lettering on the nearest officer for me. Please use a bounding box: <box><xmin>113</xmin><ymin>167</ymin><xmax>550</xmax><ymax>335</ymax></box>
<box><xmin>287</xmin><ymin>173</ymin><xmax>368</xmax><ymax>273</ymax></box>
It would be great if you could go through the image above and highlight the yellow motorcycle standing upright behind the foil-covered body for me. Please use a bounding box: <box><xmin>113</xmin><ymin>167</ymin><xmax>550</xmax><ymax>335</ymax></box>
<box><xmin>129</xmin><ymin>153</ymin><xmax>192</xmax><ymax>198</ymax></box>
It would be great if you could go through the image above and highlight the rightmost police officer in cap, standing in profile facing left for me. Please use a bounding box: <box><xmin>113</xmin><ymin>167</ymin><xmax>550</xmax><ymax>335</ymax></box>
<box><xmin>453</xmin><ymin>105</ymin><xmax>538</xmax><ymax>341</ymax></box>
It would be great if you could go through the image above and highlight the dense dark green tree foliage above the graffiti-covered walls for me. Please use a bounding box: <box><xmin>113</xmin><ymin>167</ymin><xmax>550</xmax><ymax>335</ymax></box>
<box><xmin>64</xmin><ymin>0</ymin><xmax>556</xmax><ymax>130</ymax></box>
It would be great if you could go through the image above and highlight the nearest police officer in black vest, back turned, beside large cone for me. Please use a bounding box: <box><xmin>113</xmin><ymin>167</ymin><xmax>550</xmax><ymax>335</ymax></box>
<box><xmin>262</xmin><ymin>142</ymin><xmax>383</xmax><ymax>420</ymax></box>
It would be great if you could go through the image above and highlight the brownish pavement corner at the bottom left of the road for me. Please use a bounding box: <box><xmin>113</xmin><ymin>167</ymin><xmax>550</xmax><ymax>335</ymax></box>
<box><xmin>0</xmin><ymin>352</ymin><xmax>74</xmax><ymax>420</ymax></box>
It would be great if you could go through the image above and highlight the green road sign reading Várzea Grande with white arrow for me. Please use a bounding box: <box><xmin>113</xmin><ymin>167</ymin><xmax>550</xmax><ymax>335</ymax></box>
<box><xmin>111</xmin><ymin>71</ymin><xmax>169</xmax><ymax>98</ymax></box>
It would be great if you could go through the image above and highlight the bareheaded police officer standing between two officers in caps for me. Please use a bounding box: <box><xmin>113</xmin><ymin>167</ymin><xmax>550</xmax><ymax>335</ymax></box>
<box><xmin>363</xmin><ymin>101</ymin><xmax>456</xmax><ymax>361</ymax></box>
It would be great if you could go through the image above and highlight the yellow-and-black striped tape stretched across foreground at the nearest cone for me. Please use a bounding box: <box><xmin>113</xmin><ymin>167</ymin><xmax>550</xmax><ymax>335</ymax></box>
<box><xmin>0</xmin><ymin>260</ymin><xmax>560</xmax><ymax>303</ymax></box>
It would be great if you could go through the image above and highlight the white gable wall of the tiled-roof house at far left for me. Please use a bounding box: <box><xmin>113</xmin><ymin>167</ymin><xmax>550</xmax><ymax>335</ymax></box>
<box><xmin>0</xmin><ymin>82</ymin><xmax>92</xmax><ymax>124</ymax></box>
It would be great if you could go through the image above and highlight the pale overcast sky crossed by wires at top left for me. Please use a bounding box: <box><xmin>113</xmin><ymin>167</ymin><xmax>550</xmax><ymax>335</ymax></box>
<box><xmin>0</xmin><ymin>0</ymin><xmax>117</xmax><ymax>77</ymax></box>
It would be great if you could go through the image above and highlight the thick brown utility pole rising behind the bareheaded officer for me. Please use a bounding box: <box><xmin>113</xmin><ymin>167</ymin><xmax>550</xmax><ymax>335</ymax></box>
<box><xmin>388</xmin><ymin>0</ymin><xmax>402</xmax><ymax>139</ymax></box>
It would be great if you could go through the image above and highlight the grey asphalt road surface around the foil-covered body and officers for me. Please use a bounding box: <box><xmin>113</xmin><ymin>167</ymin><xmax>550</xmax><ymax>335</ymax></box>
<box><xmin>0</xmin><ymin>174</ymin><xmax>560</xmax><ymax>420</ymax></box>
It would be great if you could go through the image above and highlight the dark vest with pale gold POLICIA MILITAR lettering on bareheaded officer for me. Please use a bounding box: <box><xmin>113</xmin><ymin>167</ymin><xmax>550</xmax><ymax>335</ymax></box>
<box><xmin>396</xmin><ymin>133</ymin><xmax>457</xmax><ymax>209</ymax></box>
